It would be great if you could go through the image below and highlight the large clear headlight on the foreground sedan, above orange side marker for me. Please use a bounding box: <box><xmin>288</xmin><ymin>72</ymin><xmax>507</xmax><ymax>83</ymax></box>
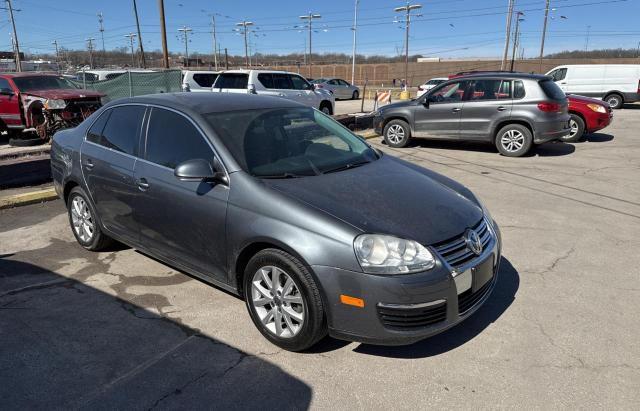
<box><xmin>353</xmin><ymin>234</ymin><xmax>436</xmax><ymax>274</ymax></box>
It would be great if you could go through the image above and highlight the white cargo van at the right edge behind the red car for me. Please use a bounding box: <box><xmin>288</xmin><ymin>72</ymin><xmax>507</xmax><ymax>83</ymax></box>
<box><xmin>547</xmin><ymin>64</ymin><xmax>640</xmax><ymax>108</ymax></box>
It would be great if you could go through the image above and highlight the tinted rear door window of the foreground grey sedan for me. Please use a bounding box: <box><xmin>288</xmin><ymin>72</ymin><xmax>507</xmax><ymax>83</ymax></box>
<box><xmin>99</xmin><ymin>105</ymin><xmax>145</xmax><ymax>156</ymax></box>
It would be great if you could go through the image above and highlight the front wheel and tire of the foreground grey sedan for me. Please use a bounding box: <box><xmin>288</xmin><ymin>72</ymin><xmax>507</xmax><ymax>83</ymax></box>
<box><xmin>244</xmin><ymin>248</ymin><xmax>327</xmax><ymax>351</ymax></box>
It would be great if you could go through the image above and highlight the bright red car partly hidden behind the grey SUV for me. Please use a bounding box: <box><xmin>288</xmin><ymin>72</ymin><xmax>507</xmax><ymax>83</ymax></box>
<box><xmin>562</xmin><ymin>94</ymin><xmax>613</xmax><ymax>143</ymax></box>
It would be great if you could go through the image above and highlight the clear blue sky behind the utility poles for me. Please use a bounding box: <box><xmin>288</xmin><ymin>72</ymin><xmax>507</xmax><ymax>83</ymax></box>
<box><xmin>0</xmin><ymin>0</ymin><xmax>640</xmax><ymax>58</ymax></box>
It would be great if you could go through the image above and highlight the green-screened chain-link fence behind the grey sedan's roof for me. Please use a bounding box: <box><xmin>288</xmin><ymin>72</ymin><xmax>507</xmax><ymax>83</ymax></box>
<box><xmin>71</xmin><ymin>70</ymin><xmax>182</xmax><ymax>100</ymax></box>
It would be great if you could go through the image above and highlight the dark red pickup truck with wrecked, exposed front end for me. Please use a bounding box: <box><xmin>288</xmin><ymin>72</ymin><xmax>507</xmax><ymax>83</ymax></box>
<box><xmin>0</xmin><ymin>73</ymin><xmax>105</xmax><ymax>142</ymax></box>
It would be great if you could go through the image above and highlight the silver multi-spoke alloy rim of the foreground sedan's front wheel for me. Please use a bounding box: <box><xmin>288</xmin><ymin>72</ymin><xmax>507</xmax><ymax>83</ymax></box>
<box><xmin>251</xmin><ymin>266</ymin><xmax>306</xmax><ymax>338</ymax></box>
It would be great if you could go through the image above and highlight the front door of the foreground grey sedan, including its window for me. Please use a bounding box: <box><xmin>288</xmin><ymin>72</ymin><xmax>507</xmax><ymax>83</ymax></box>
<box><xmin>135</xmin><ymin>107</ymin><xmax>229</xmax><ymax>283</ymax></box>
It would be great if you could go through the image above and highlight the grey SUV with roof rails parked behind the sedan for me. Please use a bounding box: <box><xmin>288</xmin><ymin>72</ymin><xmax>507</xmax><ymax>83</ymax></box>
<box><xmin>373</xmin><ymin>73</ymin><xmax>570</xmax><ymax>157</ymax></box>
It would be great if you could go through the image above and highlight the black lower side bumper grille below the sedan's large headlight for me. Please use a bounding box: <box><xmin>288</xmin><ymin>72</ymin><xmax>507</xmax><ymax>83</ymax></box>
<box><xmin>378</xmin><ymin>301</ymin><xmax>447</xmax><ymax>331</ymax></box>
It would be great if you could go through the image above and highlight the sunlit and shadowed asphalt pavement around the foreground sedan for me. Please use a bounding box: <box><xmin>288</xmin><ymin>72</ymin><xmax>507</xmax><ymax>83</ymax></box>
<box><xmin>0</xmin><ymin>105</ymin><xmax>640</xmax><ymax>409</ymax></box>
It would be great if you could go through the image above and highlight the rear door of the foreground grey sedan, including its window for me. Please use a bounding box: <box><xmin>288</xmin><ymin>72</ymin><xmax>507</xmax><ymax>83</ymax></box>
<box><xmin>80</xmin><ymin>104</ymin><xmax>146</xmax><ymax>243</ymax></box>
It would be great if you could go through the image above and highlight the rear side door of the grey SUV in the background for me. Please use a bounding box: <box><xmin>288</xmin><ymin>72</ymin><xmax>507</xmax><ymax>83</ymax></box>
<box><xmin>459</xmin><ymin>79</ymin><xmax>513</xmax><ymax>141</ymax></box>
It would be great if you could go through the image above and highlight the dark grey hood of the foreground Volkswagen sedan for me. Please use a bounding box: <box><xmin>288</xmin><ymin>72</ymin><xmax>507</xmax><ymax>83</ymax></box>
<box><xmin>263</xmin><ymin>155</ymin><xmax>482</xmax><ymax>244</ymax></box>
